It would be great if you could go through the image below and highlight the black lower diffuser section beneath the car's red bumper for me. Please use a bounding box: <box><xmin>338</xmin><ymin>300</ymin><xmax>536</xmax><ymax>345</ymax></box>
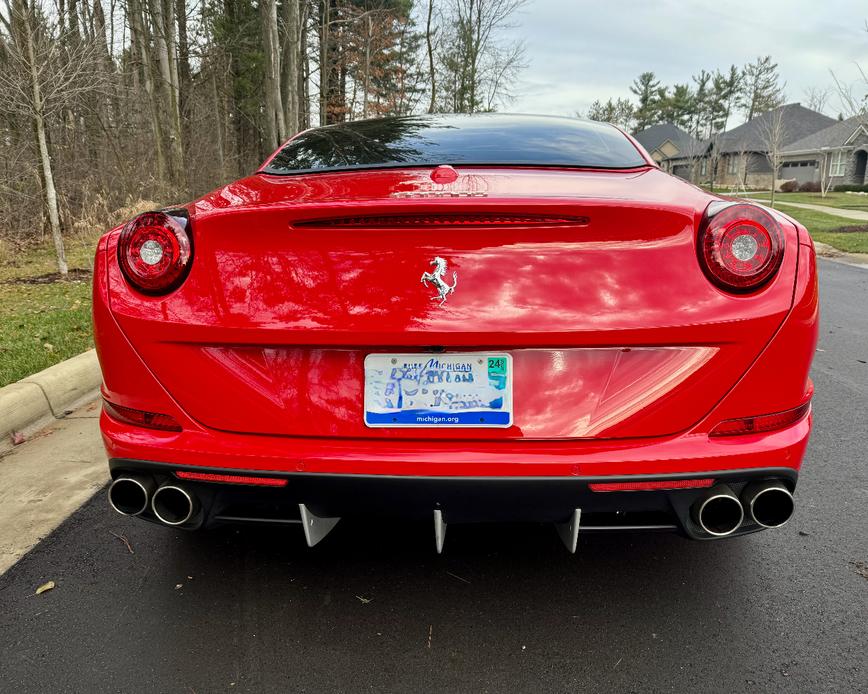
<box><xmin>110</xmin><ymin>459</ymin><xmax>798</xmax><ymax>540</ymax></box>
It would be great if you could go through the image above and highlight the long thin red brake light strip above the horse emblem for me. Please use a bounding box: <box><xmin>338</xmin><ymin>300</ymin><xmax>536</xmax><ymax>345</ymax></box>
<box><xmin>293</xmin><ymin>214</ymin><xmax>590</xmax><ymax>229</ymax></box>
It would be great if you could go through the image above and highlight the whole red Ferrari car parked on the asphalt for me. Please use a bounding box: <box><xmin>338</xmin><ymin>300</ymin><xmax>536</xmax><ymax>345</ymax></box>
<box><xmin>93</xmin><ymin>115</ymin><xmax>818</xmax><ymax>551</ymax></box>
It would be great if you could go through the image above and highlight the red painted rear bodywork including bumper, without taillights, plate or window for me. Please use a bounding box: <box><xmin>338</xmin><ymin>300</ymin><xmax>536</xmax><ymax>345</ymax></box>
<box><xmin>94</xmin><ymin>118</ymin><xmax>818</xmax><ymax>540</ymax></box>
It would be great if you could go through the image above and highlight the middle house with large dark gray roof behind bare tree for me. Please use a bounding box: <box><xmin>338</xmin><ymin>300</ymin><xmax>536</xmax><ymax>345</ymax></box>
<box><xmin>699</xmin><ymin>103</ymin><xmax>835</xmax><ymax>188</ymax></box>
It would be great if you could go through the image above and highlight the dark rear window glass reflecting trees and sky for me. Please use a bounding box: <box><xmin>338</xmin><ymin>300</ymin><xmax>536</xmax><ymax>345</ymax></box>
<box><xmin>262</xmin><ymin>114</ymin><xmax>647</xmax><ymax>174</ymax></box>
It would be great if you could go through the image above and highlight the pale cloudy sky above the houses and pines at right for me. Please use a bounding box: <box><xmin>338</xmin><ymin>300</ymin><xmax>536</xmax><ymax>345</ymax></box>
<box><xmin>501</xmin><ymin>0</ymin><xmax>868</xmax><ymax>122</ymax></box>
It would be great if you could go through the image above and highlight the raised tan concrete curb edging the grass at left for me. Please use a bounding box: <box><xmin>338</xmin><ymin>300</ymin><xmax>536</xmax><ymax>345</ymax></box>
<box><xmin>0</xmin><ymin>350</ymin><xmax>102</xmax><ymax>452</ymax></box>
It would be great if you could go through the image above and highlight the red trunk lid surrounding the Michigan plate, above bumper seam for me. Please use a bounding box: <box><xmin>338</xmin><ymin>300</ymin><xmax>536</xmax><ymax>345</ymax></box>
<box><xmin>111</xmin><ymin>170</ymin><xmax>795</xmax><ymax>439</ymax></box>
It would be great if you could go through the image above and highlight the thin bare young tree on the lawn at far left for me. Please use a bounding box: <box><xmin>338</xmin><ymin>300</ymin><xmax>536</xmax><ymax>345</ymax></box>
<box><xmin>0</xmin><ymin>0</ymin><xmax>106</xmax><ymax>276</ymax></box>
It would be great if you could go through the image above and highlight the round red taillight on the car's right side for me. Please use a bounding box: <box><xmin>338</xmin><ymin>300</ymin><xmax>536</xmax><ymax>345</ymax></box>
<box><xmin>697</xmin><ymin>203</ymin><xmax>784</xmax><ymax>293</ymax></box>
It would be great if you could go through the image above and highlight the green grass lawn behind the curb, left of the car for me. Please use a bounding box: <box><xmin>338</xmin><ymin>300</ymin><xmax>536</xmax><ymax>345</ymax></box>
<box><xmin>0</xmin><ymin>238</ymin><xmax>96</xmax><ymax>387</ymax></box>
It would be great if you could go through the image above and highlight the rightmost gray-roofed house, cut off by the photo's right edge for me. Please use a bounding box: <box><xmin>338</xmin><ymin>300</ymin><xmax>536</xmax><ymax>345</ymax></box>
<box><xmin>780</xmin><ymin>115</ymin><xmax>868</xmax><ymax>188</ymax></box>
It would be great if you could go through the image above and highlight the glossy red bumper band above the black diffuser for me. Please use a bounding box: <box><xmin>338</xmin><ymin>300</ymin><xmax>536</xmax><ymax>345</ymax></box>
<box><xmin>100</xmin><ymin>412</ymin><xmax>812</xmax><ymax>478</ymax></box>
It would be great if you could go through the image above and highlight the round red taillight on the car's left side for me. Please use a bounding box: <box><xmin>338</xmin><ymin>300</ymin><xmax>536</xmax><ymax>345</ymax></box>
<box><xmin>118</xmin><ymin>212</ymin><xmax>193</xmax><ymax>294</ymax></box>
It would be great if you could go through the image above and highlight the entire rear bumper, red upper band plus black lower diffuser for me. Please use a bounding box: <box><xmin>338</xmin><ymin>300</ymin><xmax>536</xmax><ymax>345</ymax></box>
<box><xmin>102</xmin><ymin>414</ymin><xmax>811</xmax><ymax>539</ymax></box>
